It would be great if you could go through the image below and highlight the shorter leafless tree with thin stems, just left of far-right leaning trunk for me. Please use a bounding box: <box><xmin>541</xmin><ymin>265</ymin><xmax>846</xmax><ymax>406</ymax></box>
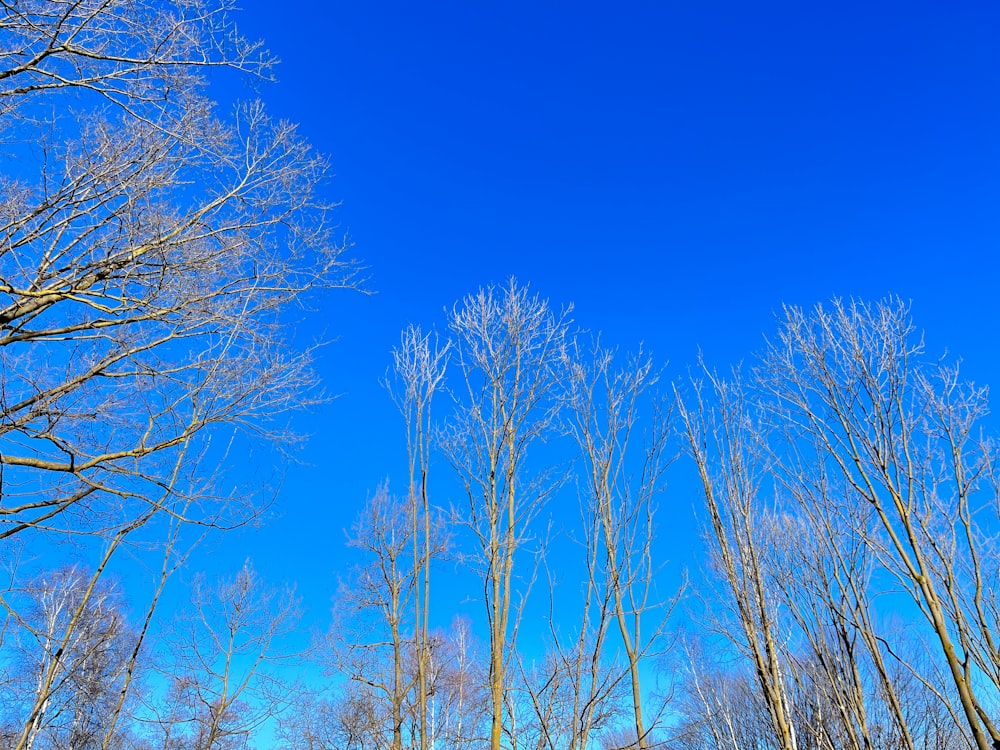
<box><xmin>761</xmin><ymin>471</ymin><xmax>914</xmax><ymax>750</ymax></box>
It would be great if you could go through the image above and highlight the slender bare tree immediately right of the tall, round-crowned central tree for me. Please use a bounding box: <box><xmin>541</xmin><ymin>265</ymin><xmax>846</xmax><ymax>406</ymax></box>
<box><xmin>567</xmin><ymin>344</ymin><xmax>683</xmax><ymax>750</ymax></box>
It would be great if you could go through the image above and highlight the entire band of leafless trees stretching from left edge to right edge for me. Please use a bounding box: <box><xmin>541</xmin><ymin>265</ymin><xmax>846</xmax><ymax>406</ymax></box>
<box><xmin>0</xmin><ymin>0</ymin><xmax>1000</xmax><ymax>750</ymax></box>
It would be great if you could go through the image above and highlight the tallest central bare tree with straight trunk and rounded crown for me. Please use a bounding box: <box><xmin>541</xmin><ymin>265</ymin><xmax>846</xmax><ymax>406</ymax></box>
<box><xmin>443</xmin><ymin>280</ymin><xmax>567</xmax><ymax>750</ymax></box>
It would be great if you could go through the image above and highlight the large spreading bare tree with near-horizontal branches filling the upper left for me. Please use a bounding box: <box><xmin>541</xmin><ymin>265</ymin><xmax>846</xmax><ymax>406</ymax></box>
<box><xmin>0</xmin><ymin>0</ymin><xmax>355</xmax><ymax>538</ymax></box>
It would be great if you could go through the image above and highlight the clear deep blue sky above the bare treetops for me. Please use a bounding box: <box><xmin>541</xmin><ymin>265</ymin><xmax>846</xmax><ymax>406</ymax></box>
<box><xmin>199</xmin><ymin>0</ymin><xmax>1000</xmax><ymax>636</ymax></box>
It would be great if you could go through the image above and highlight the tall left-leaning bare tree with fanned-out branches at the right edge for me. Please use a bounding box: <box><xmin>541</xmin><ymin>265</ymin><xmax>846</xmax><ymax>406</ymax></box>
<box><xmin>758</xmin><ymin>300</ymin><xmax>1000</xmax><ymax>750</ymax></box>
